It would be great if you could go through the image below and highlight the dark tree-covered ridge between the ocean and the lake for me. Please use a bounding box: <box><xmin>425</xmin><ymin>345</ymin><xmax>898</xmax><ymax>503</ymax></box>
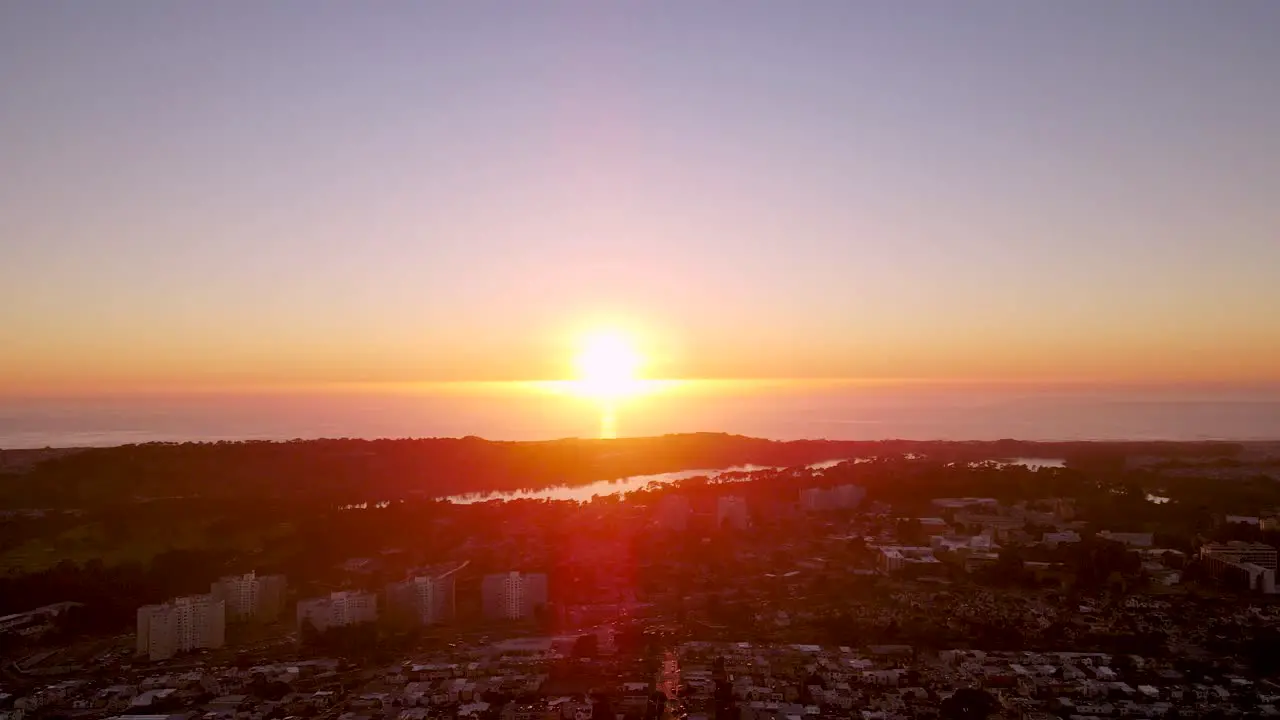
<box><xmin>0</xmin><ymin>433</ymin><xmax>1242</xmax><ymax>509</ymax></box>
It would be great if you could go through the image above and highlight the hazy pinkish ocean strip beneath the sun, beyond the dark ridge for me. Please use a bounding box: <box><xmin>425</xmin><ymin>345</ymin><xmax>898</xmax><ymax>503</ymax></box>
<box><xmin>0</xmin><ymin>380</ymin><xmax>1280</xmax><ymax>448</ymax></box>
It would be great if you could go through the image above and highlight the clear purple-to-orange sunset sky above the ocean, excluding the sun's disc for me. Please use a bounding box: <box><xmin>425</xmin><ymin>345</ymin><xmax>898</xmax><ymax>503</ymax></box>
<box><xmin>0</xmin><ymin>0</ymin><xmax>1280</xmax><ymax>392</ymax></box>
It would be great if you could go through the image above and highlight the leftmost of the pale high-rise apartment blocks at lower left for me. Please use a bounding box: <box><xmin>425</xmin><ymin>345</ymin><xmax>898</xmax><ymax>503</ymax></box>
<box><xmin>137</xmin><ymin>594</ymin><xmax>227</xmax><ymax>660</ymax></box>
